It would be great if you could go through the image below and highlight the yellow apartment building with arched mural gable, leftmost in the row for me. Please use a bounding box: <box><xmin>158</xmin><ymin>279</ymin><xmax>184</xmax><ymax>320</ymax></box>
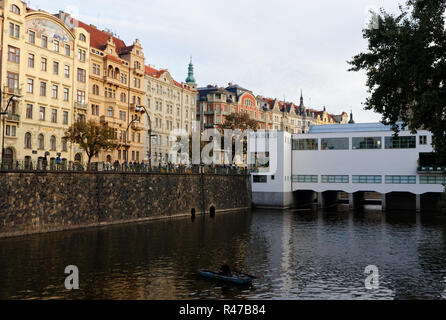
<box><xmin>0</xmin><ymin>0</ymin><xmax>90</xmax><ymax>168</ymax></box>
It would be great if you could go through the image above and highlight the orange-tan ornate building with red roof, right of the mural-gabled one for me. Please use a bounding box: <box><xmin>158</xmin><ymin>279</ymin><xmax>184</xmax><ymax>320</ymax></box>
<box><xmin>70</xmin><ymin>17</ymin><xmax>146</xmax><ymax>163</ymax></box>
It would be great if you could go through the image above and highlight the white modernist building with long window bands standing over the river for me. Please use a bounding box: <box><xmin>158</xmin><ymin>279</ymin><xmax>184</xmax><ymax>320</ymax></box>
<box><xmin>248</xmin><ymin>123</ymin><xmax>446</xmax><ymax>210</ymax></box>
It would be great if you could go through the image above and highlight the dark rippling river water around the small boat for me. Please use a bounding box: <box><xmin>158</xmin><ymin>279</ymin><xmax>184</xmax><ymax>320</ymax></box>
<box><xmin>0</xmin><ymin>207</ymin><xmax>446</xmax><ymax>300</ymax></box>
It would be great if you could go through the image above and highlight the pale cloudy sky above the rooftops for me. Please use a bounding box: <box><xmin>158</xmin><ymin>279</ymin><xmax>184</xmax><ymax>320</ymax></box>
<box><xmin>27</xmin><ymin>0</ymin><xmax>405</xmax><ymax>122</ymax></box>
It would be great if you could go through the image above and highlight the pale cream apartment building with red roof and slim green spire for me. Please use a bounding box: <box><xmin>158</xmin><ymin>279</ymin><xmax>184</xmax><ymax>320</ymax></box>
<box><xmin>143</xmin><ymin>61</ymin><xmax>198</xmax><ymax>164</ymax></box>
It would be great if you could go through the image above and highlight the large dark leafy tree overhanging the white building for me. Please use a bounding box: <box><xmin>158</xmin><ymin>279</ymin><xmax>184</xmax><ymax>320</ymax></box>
<box><xmin>348</xmin><ymin>0</ymin><xmax>446</xmax><ymax>159</ymax></box>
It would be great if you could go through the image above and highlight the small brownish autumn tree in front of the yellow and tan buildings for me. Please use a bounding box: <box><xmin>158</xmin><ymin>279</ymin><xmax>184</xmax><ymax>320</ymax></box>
<box><xmin>64</xmin><ymin>120</ymin><xmax>119</xmax><ymax>164</ymax></box>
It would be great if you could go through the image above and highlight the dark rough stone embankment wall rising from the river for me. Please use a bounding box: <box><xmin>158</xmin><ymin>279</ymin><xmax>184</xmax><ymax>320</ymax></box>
<box><xmin>0</xmin><ymin>172</ymin><xmax>251</xmax><ymax>238</ymax></box>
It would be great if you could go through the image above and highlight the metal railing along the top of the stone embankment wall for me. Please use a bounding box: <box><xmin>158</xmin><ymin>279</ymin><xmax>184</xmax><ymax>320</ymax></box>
<box><xmin>0</xmin><ymin>159</ymin><xmax>250</xmax><ymax>175</ymax></box>
